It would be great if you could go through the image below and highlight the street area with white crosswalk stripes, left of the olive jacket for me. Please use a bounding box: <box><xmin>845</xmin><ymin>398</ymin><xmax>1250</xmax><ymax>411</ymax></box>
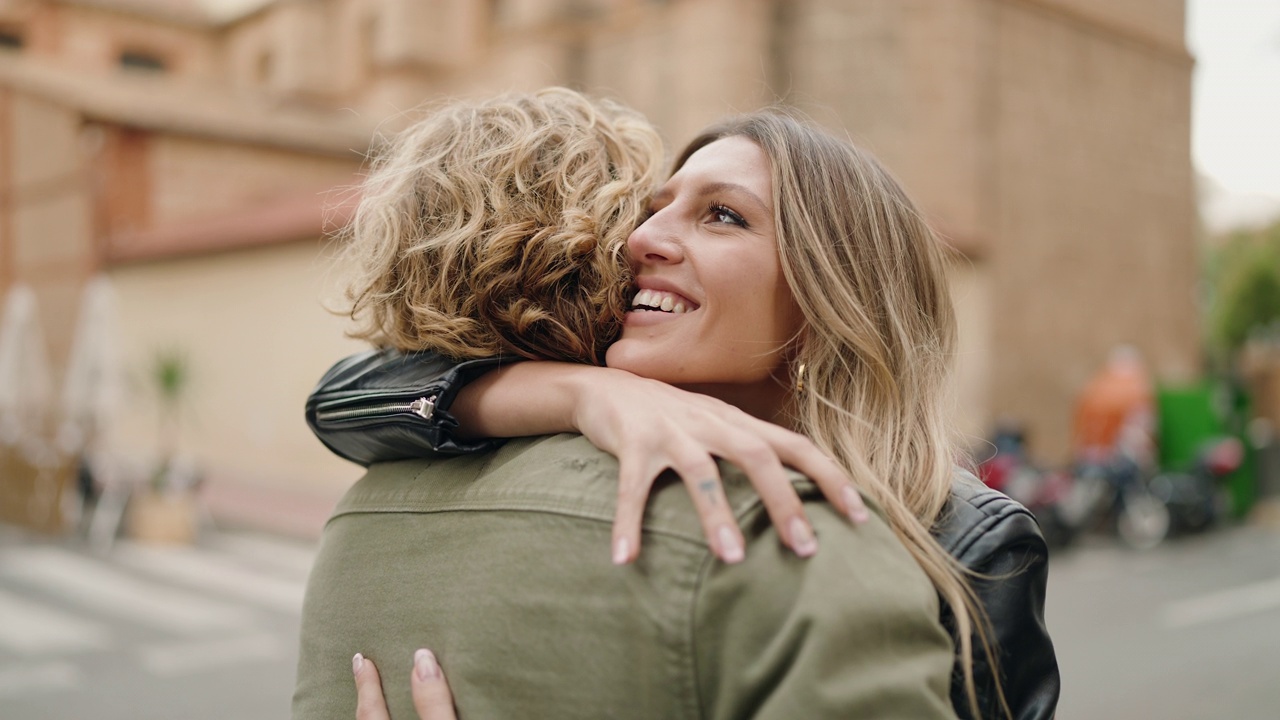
<box><xmin>0</xmin><ymin>527</ymin><xmax>314</xmax><ymax>720</ymax></box>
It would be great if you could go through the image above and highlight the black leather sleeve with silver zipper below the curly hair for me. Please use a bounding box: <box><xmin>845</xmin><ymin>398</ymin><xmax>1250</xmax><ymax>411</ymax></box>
<box><xmin>306</xmin><ymin>350</ymin><xmax>517</xmax><ymax>466</ymax></box>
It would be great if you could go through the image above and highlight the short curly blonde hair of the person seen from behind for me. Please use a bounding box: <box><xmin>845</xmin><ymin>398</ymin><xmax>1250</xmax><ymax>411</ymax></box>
<box><xmin>339</xmin><ymin>87</ymin><xmax>663</xmax><ymax>364</ymax></box>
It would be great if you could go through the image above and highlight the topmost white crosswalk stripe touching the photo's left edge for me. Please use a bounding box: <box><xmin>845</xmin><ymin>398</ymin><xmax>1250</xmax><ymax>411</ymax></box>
<box><xmin>0</xmin><ymin>547</ymin><xmax>252</xmax><ymax>633</ymax></box>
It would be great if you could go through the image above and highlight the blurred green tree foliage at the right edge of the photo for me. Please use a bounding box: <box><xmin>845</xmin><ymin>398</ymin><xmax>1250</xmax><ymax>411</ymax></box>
<box><xmin>1210</xmin><ymin>222</ymin><xmax>1280</xmax><ymax>355</ymax></box>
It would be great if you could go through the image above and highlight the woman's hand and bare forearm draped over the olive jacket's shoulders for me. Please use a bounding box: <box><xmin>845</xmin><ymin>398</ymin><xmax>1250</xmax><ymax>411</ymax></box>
<box><xmin>453</xmin><ymin>363</ymin><xmax>868</xmax><ymax>565</ymax></box>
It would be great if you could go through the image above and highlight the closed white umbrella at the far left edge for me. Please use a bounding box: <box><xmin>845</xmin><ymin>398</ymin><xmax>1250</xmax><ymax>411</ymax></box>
<box><xmin>0</xmin><ymin>284</ymin><xmax>54</xmax><ymax>446</ymax></box>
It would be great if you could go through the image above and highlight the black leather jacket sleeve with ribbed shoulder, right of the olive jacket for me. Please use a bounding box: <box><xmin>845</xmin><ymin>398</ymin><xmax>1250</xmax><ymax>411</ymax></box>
<box><xmin>933</xmin><ymin>471</ymin><xmax>1061</xmax><ymax>720</ymax></box>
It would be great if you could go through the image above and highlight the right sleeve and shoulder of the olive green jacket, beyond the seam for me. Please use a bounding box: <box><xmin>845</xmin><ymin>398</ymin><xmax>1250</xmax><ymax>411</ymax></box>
<box><xmin>694</xmin><ymin>502</ymin><xmax>955</xmax><ymax>720</ymax></box>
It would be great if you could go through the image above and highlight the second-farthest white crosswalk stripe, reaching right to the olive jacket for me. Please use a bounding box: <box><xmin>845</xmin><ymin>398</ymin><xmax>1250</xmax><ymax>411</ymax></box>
<box><xmin>111</xmin><ymin>543</ymin><xmax>306</xmax><ymax>614</ymax></box>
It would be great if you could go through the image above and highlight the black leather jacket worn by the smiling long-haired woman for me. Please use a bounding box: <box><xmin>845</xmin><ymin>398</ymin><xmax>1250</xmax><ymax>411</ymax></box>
<box><xmin>306</xmin><ymin>351</ymin><xmax>1060</xmax><ymax>720</ymax></box>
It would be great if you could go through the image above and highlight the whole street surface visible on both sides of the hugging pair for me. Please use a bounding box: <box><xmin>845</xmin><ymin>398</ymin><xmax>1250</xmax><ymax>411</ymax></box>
<box><xmin>0</xmin><ymin>512</ymin><xmax>1280</xmax><ymax>720</ymax></box>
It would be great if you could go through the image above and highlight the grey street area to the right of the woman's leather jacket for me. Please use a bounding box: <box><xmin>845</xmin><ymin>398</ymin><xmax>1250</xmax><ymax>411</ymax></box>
<box><xmin>1047</xmin><ymin>517</ymin><xmax>1280</xmax><ymax>720</ymax></box>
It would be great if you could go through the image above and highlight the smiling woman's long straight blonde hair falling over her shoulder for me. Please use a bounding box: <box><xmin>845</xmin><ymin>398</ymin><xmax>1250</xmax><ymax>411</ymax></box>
<box><xmin>675</xmin><ymin>109</ymin><xmax>1007</xmax><ymax>715</ymax></box>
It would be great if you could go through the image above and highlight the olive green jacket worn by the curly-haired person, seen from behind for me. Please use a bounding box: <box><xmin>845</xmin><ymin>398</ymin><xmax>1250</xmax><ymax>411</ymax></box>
<box><xmin>293</xmin><ymin>436</ymin><xmax>954</xmax><ymax>720</ymax></box>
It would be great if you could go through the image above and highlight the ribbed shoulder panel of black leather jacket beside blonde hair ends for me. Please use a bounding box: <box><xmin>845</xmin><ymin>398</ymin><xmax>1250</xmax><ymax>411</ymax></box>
<box><xmin>933</xmin><ymin>469</ymin><xmax>1047</xmax><ymax>569</ymax></box>
